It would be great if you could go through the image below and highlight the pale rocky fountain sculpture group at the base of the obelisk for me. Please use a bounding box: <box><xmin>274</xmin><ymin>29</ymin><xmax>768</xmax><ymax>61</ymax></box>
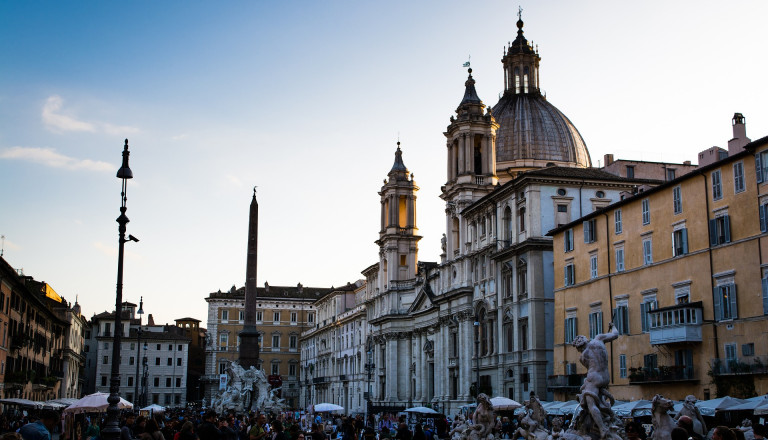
<box><xmin>211</xmin><ymin>361</ymin><xmax>285</xmax><ymax>414</ymax></box>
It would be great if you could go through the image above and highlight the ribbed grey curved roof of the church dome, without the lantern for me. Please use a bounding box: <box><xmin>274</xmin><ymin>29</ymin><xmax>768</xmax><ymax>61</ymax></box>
<box><xmin>493</xmin><ymin>93</ymin><xmax>592</xmax><ymax>167</ymax></box>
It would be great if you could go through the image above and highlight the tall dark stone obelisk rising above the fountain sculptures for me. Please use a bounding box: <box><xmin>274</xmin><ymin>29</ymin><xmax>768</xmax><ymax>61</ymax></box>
<box><xmin>239</xmin><ymin>187</ymin><xmax>259</xmax><ymax>370</ymax></box>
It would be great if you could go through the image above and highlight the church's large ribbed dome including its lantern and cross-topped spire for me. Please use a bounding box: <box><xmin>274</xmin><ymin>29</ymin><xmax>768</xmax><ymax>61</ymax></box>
<box><xmin>492</xmin><ymin>19</ymin><xmax>592</xmax><ymax>171</ymax></box>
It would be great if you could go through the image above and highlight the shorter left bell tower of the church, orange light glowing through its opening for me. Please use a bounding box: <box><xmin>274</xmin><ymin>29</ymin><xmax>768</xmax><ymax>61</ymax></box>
<box><xmin>376</xmin><ymin>141</ymin><xmax>421</xmax><ymax>290</ymax></box>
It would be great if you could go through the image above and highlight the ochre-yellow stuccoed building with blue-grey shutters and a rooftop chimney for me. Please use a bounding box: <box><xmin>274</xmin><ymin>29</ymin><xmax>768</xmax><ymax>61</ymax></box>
<box><xmin>548</xmin><ymin>128</ymin><xmax>768</xmax><ymax>400</ymax></box>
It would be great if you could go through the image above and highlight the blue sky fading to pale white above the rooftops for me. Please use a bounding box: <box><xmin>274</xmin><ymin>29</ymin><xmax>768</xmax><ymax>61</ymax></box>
<box><xmin>0</xmin><ymin>0</ymin><xmax>768</xmax><ymax>325</ymax></box>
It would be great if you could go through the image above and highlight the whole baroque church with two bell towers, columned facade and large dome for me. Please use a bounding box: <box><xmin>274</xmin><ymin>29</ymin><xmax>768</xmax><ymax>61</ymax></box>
<box><xmin>342</xmin><ymin>20</ymin><xmax>656</xmax><ymax>414</ymax></box>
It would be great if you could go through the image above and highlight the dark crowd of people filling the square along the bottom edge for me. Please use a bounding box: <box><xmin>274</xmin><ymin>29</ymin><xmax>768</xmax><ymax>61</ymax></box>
<box><xmin>0</xmin><ymin>410</ymin><xmax>766</xmax><ymax>440</ymax></box>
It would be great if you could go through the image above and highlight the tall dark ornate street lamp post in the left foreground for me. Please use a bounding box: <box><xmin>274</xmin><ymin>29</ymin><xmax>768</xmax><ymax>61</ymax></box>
<box><xmin>101</xmin><ymin>139</ymin><xmax>139</xmax><ymax>440</ymax></box>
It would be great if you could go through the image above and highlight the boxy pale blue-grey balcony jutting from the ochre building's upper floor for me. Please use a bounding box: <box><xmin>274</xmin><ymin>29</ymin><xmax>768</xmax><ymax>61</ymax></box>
<box><xmin>648</xmin><ymin>301</ymin><xmax>702</xmax><ymax>345</ymax></box>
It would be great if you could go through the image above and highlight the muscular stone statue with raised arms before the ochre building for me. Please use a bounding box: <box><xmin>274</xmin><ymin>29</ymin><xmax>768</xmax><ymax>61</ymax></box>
<box><xmin>565</xmin><ymin>322</ymin><xmax>624</xmax><ymax>440</ymax></box>
